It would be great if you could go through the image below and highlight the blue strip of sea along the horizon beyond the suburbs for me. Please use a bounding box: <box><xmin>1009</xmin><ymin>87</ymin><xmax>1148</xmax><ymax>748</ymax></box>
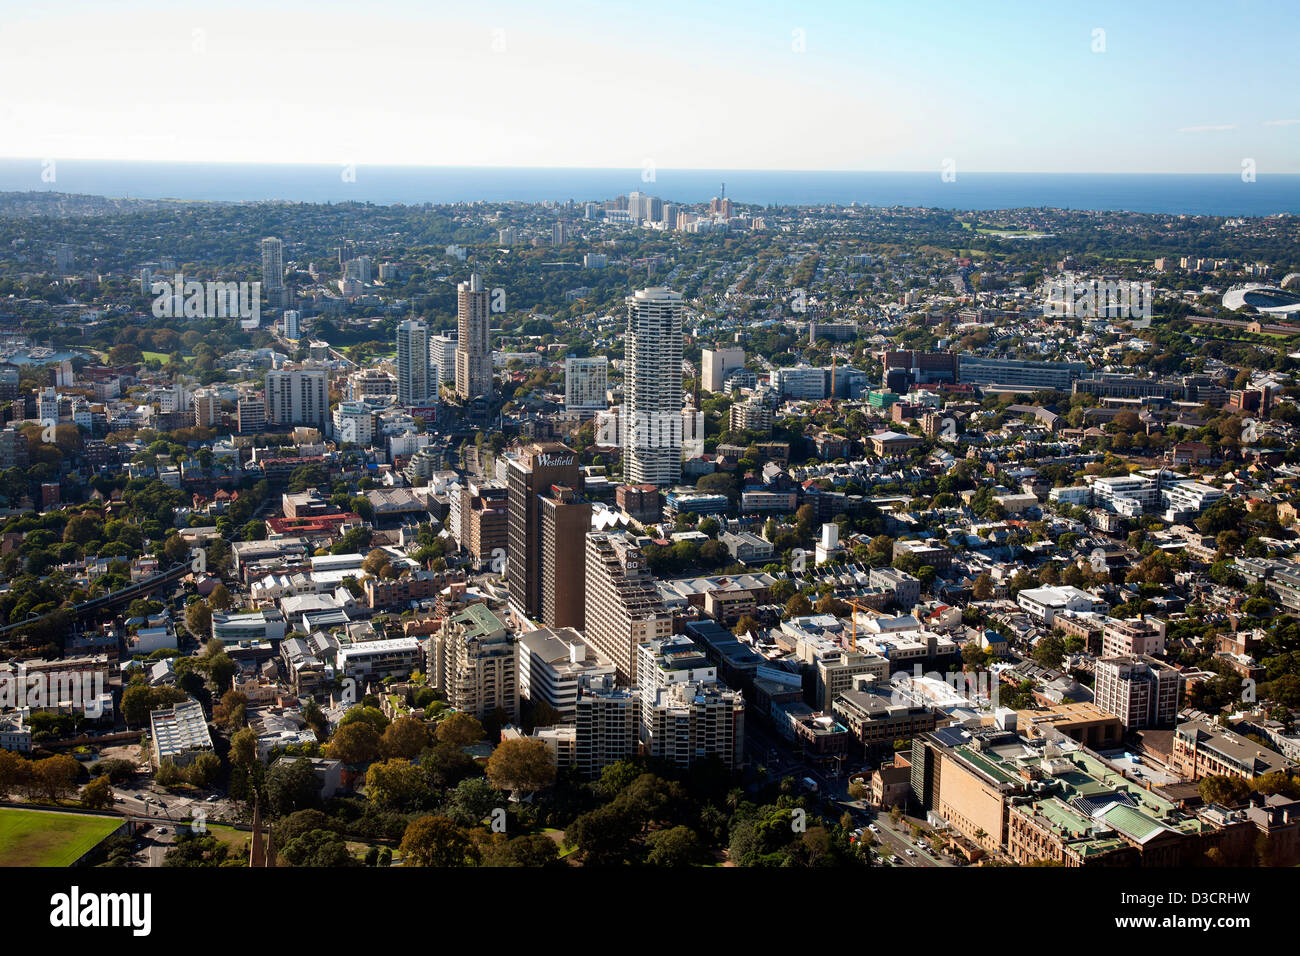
<box><xmin>0</xmin><ymin>159</ymin><xmax>1300</xmax><ymax>216</ymax></box>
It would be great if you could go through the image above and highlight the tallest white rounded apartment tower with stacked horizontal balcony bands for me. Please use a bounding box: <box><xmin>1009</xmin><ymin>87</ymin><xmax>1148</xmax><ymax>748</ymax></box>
<box><xmin>623</xmin><ymin>286</ymin><xmax>683</xmax><ymax>485</ymax></box>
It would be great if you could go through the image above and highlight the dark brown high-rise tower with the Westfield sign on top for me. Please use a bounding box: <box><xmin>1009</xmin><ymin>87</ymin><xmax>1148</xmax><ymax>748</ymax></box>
<box><xmin>506</xmin><ymin>442</ymin><xmax>592</xmax><ymax>627</ymax></box>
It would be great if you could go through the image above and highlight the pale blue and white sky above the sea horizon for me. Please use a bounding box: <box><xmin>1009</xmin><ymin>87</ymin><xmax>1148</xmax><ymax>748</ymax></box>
<box><xmin>0</xmin><ymin>0</ymin><xmax>1300</xmax><ymax>176</ymax></box>
